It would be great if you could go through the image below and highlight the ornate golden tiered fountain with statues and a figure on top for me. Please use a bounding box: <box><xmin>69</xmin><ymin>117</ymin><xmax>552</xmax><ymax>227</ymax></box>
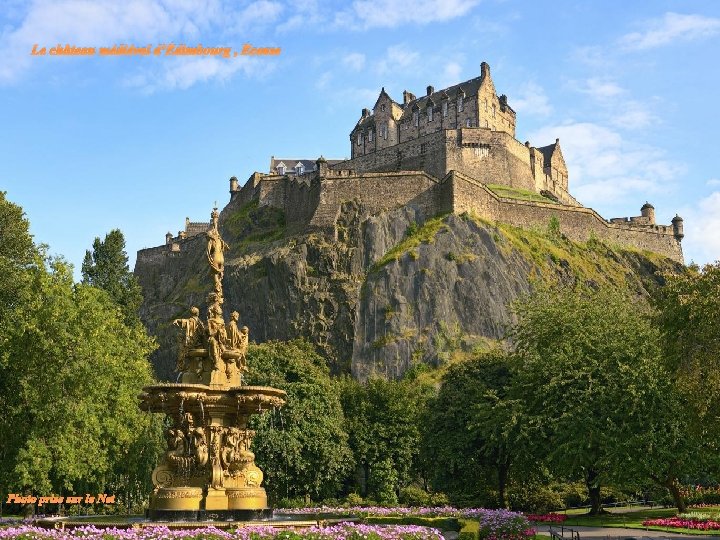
<box><xmin>140</xmin><ymin>208</ymin><xmax>286</xmax><ymax>521</ymax></box>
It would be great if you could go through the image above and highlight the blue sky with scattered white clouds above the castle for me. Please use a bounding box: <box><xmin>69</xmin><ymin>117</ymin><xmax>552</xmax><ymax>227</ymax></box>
<box><xmin>0</xmin><ymin>0</ymin><xmax>720</xmax><ymax>277</ymax></box>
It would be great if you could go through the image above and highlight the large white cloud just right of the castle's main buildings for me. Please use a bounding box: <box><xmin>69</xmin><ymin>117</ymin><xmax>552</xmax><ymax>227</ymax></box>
<box><xmin>530</xmin><ymin>122</ymin><xmax>683</xmax><ymax>206</ymax></box>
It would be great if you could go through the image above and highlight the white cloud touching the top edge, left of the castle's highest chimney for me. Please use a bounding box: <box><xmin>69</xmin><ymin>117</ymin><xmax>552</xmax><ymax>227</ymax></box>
<box><xmin>335</xmin><ymin>0</ymin><xmax>479</xmax><ymax>29</ymax></box>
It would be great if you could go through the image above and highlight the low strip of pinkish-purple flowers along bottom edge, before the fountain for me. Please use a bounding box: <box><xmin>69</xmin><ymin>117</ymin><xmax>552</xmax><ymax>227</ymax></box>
<box><xmin>0</xmin><ymin>523</ymin><xmax>443</xmax><ymax>540</ymax></box>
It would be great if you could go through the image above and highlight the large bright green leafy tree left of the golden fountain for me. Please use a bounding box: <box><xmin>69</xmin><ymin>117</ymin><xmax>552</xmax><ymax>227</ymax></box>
<box><xmin>0</xmin><ymin>260</ymin><xmax>160</xmax><ymax>504</ymax></box>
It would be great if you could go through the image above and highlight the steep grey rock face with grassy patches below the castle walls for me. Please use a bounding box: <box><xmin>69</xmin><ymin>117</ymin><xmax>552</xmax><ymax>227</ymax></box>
<box><xmin>135</xmin><ymin>197</ymin><xmax>681</xmax><ymax>380</ymax></box>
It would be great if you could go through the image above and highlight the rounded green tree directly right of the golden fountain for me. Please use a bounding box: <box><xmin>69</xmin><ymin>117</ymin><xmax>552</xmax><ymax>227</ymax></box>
<box><xmin>248</xmin><ymin>340</ymin><xmax>352</xmax><ymax>501</ymax></box>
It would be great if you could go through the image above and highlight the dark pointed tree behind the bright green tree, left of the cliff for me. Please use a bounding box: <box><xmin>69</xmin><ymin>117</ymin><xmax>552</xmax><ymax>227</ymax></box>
<box><xmin>82</xmin><ymin>229</ymin><xmax>142</xmax><ymax>324</ymax></box>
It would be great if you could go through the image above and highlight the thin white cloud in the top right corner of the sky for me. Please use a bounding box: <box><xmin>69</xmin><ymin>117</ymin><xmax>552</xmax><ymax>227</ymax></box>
<box><xmin>620</xmin><ymin>12</ymin><xmax>720</xmax><ymax>50</ymax></box>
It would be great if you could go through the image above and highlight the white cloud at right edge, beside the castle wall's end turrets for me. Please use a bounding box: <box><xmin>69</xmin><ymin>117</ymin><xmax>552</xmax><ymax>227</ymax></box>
<box><xmin>683</xmin><ymin>191</ymin><xmax>720</xmax><ymax>264</ymax></box>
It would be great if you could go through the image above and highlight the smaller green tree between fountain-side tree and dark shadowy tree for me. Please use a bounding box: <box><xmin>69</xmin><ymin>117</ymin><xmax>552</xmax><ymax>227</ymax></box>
<box><xmin>341</xmin><ymin>378</ymin><xmax>431</xmax><ymax>504</ymax></box>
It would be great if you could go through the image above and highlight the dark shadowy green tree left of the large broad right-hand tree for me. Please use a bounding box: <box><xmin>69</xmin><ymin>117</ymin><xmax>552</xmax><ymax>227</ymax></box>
<box><xmin>422</xmin><ymin>351</ymin><xmax>522</xmax><ymax>507</ymax></box>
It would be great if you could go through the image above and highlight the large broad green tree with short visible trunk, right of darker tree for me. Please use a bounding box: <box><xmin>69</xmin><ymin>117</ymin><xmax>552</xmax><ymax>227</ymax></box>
<box><xmin>513</xmin><ymin>288</ymin><xmax>669</xmax><ymax>514</ymax></box>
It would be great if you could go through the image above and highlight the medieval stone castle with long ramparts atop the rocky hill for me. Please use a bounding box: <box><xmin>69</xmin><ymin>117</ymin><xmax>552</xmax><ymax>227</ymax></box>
<box><xmin>156</xmin><ymin>62</ymin><xmax>683</xmax><ymax>262</ymax></box>
